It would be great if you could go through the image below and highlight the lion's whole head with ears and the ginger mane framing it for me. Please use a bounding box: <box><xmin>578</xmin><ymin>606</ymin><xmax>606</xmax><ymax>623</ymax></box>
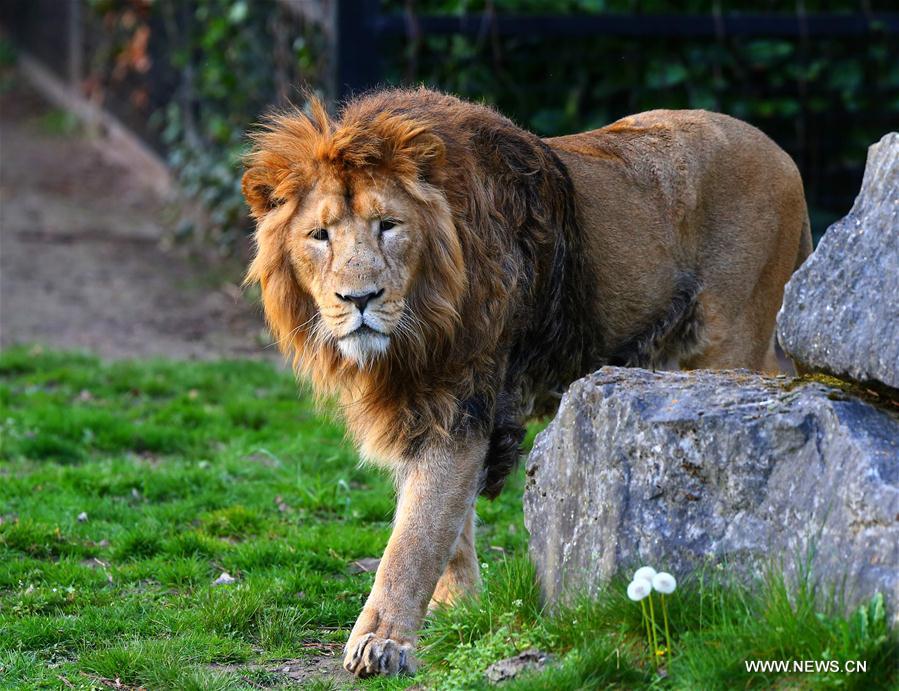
<box><xmin>242</xmin><ymin>94</ymin><xmax>469</xmax><ymax>382</ymax></box>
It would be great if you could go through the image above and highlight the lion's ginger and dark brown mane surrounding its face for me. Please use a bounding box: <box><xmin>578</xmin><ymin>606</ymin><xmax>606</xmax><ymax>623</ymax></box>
<box><xmin>243</xmin><ymin>89</ymin><xmax>596</xmax><ymax>496</ymax></box>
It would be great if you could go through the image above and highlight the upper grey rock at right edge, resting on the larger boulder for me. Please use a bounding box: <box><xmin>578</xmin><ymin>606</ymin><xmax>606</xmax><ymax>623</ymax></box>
<box><xmin>777</xmin><ymin>132</ymin><xmax>899</xmax><ymax>389</ymax></box>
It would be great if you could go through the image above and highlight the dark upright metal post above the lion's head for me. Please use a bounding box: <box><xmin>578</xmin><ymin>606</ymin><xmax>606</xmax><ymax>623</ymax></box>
<box><xmin>335</xmin><ymin>0</ymin><xmax>381</xmax><ymax>99</ymax></box>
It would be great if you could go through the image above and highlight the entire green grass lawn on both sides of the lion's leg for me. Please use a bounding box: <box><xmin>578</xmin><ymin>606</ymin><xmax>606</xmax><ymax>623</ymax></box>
<box><xmin>0</xmin><ymin>348</ymin><xmax>899</xmax><ymax>689</ymax></box>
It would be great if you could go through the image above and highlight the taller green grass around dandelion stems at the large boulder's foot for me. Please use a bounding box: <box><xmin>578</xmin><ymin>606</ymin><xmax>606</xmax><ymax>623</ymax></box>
<box><xmin>423</xmin><ymin>559</ymin><xmax>899</xmax><ymax>689</ymax></box>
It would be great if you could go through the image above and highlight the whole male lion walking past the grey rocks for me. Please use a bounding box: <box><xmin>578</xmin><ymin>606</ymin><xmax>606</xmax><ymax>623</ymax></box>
<box><xmin>242</xmin><ymin>88</ymin><xmax>811</xmax><ymax>676</ymax></box>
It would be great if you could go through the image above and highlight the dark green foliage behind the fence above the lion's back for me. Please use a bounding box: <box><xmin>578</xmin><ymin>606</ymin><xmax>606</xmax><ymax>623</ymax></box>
<box><xmin>390</xmin><ymin>0</ymin><xmax>899</xmax><ymax>235</ymax></box>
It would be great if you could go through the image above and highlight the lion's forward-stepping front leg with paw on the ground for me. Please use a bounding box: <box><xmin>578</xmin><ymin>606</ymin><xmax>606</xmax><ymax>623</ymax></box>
<box><xmin>343</xmin><ymin>440</ymin><xmax>486</xmax><ymax>676</ymax></box>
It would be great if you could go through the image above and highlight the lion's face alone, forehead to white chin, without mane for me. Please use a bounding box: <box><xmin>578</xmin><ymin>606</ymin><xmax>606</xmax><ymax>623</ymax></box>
<box><xmin>287</xmin><ymin>178</ymin><xmax>425</xmax><ymax>365</ymax></box>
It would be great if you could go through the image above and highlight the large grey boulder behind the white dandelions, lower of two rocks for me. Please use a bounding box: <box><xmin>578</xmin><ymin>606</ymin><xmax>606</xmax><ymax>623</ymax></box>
<box><xmin>524</xmin><ymin>367</ymin><xmax>899</xmax><ymax>617</ymax></box>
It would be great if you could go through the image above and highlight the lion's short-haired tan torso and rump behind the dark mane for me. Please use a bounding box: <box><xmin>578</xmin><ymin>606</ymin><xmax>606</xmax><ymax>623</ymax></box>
<box><xmin>546</xmin><ymin>110</ymin><xmax>807</xmax><ymax>356</ymax></box>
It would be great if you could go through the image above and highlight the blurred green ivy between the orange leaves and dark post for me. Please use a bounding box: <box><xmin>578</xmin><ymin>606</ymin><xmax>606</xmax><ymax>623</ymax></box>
<box><xmin>148</xmin><ymin>0</ymin><xmax>326</xmax><ymax>246</ymax></box>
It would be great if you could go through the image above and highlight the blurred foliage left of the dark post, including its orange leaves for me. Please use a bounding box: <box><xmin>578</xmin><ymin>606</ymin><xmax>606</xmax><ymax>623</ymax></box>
<box><xmin>81</xmin><ymin>0</ymin><xmax>325</xmax><ymax>250</ymax></box>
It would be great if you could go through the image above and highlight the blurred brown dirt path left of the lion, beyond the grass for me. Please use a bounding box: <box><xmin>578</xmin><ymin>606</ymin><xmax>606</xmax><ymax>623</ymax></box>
<box><xmin>0</xmin><ymin>80</ymin><xmax>273</xmax><ymax>358</ymax></box>
